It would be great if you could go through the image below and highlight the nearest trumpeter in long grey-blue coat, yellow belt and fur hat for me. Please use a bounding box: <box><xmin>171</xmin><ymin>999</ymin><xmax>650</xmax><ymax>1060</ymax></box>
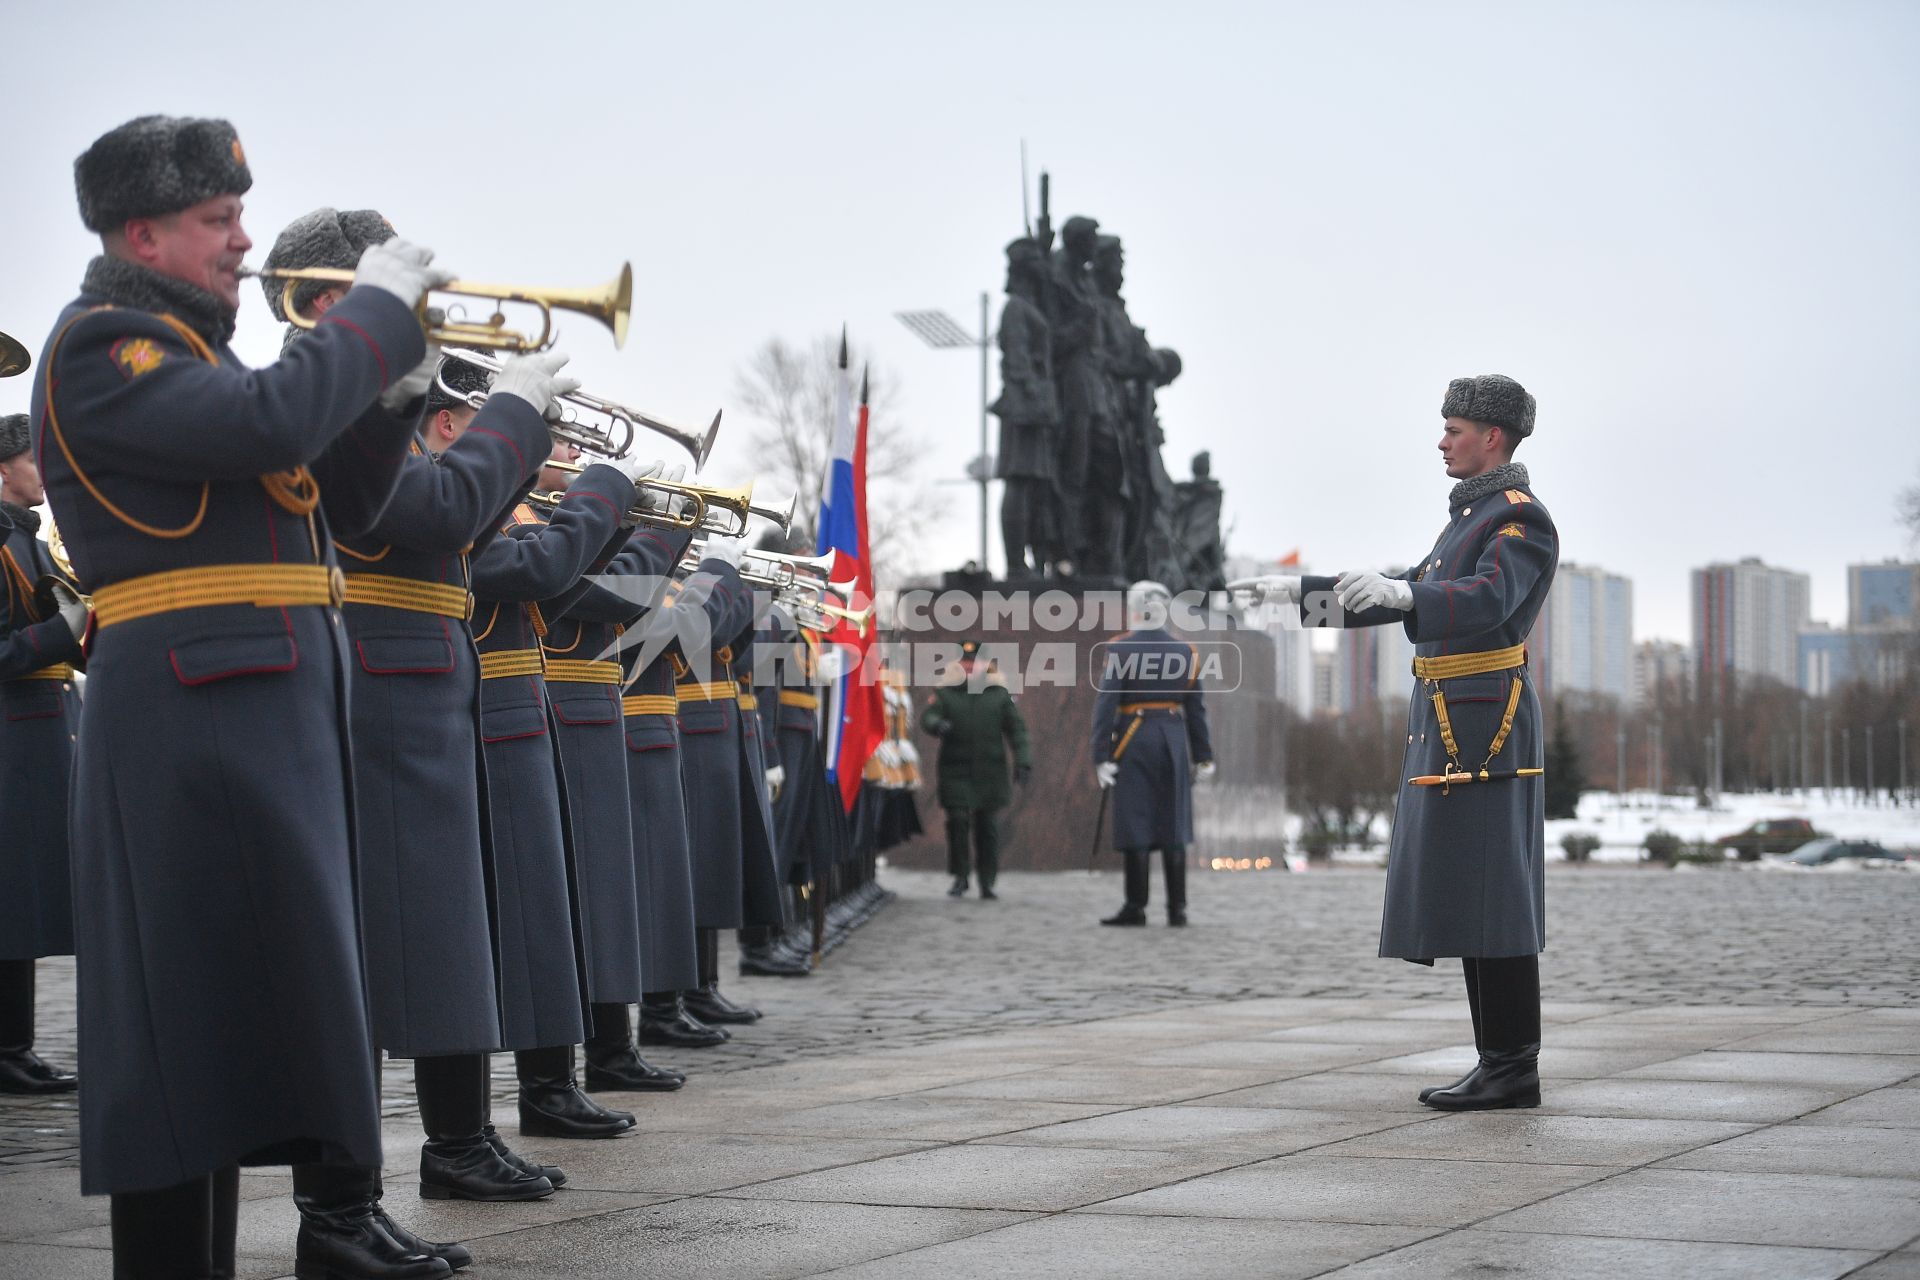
<box><xmin>33</xmin><ymin>117</ymin><xmax>460</xmax><ymax>1276</ymax></box>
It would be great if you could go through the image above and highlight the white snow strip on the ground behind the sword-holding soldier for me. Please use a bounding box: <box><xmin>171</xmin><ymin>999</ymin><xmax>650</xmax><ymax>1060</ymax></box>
<box><xmin>1320</xmin><ymin>789</ymin><xmax>1920</xmax><ymax>865</ymax></box>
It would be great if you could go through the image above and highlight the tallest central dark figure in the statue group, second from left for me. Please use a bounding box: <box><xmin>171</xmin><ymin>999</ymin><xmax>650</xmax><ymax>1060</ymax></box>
<box><xmin>1046</xmin><ymin>217</ymin><xmax>1108</xmax><ymax>570</ymax></box>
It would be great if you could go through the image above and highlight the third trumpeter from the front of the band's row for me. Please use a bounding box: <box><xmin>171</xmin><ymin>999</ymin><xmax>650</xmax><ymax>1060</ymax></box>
<box><xmin>472</xmin><ymin>437</ymin><xmax>659</xmax><ymax>1138</ymax></box>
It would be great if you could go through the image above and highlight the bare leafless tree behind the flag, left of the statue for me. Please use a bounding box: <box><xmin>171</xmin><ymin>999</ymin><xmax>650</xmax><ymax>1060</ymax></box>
<box><xmin>733</xmin><ymin>334</ymin><xmax>945</xmax><ymax>580</ymax></box>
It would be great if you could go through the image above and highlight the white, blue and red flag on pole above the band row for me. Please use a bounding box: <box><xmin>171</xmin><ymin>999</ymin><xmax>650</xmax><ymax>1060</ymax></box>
<box><xmin>814</xmin><ymin>328</ymin><xmax>887</xmax><ymax>814</ymax></box>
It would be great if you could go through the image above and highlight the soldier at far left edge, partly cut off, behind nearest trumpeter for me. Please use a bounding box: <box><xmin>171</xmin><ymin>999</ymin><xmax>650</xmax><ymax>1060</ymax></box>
<box><xmin>0</xmin><ymin>413</ymin><xmax>86</xmax><ymax>1094</ymax></box>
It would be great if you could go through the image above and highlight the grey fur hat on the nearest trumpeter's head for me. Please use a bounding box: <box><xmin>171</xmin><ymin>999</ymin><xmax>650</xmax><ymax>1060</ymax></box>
<box><xmin>73</xmin><ymin>115</ymin><xmax>253</xmax><ymax>234</ymax></box>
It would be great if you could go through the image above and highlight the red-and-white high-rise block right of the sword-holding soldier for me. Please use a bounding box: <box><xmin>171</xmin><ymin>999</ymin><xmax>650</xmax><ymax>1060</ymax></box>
<box><xmin>1692</xmin><ymin>557</ymin><xmax>1811</xmax><ymax>700</ymax></box>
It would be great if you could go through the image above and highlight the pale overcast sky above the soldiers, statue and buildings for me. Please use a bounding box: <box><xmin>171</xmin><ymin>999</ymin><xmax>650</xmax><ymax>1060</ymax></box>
<box><xmin>0</xmin><ymin>0</ymin><xmax>1920</xmax><ymax>639</ymax></box>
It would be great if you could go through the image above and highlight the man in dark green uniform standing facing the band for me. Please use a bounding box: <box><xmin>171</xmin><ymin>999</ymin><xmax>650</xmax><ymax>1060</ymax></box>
<box><xmin>920</xmin><ymin>641</ymin><xmax>1033</xmax><ymax>898</ymax></box>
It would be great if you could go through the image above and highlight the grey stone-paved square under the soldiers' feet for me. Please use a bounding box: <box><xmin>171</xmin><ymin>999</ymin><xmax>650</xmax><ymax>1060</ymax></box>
<box><xmin>0</xmin><ymin>867</ymin><xmax>1920</xmax><ymax>1280</ymax></box>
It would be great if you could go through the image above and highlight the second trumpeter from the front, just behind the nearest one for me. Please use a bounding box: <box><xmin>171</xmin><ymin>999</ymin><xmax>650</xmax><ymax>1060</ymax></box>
<box><xmin>263</xmin><ymin>209</ymin><xmax>564</xmax><ymax>1199</ymax></box>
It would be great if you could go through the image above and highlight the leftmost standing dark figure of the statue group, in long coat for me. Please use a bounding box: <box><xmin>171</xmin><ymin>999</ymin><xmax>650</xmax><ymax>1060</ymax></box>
<box><xmin>991</xmin><ymin>236</ymin><xmax>1066</xmax><ymax>578</ymax></box>
